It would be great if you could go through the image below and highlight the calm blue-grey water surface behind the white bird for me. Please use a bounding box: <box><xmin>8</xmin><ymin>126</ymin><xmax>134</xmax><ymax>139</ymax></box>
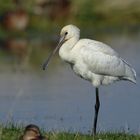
<box><xmin>0</xmin><ymin>34</ymin><xmax>140</xmax><ymax>133</ymax></box>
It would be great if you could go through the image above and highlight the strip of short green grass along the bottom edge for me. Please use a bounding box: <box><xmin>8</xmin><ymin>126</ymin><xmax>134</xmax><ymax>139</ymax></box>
<box><xmin>0</xmin><ymin>125</ymin><xmax>140</xmax><ymax>140</ymax></box>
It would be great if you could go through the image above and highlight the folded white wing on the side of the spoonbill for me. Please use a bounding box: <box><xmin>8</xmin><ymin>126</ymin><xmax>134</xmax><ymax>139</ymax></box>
<box><xmin>80</xmin><ymin>40</ymin><xmax>125</xmax><ymax>77</ymax></box>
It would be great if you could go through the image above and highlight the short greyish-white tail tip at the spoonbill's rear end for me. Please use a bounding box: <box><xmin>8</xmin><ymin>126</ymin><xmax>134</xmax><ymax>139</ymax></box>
<box><xmin>123</xmin><ymin>62</ymin><xmax>136</xmax><ymax>84</ymax></box>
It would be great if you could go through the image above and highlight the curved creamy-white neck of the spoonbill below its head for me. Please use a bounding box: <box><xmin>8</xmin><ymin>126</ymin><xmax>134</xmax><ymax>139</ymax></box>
<box><xmin>59</xmin><ymin>36</ymin><xmax>79</xmax><ymax>63</ymax></box>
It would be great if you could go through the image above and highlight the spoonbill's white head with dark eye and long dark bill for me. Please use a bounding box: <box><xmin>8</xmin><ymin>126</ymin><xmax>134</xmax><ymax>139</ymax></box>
<box><xmin>43</xmin><ymin>25</ymin><xmax>80</xmax><ymax>70</ymax></box>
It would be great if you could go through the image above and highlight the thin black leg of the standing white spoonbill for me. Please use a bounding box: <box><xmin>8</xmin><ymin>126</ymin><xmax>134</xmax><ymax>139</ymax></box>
<box><xmin>92</xmin><ymin>88</ymin><xmax>100</xmax><ymax>136</ymax></box>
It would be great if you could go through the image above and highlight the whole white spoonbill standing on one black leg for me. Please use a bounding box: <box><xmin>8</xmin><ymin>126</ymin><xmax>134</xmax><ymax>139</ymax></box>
<box><xmin>43</xmin><ymin>25</ymin><xmax>136</xmax><ymax>135</ymax></box>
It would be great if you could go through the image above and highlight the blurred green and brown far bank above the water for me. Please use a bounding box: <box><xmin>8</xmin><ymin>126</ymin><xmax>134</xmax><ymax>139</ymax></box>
<box><xmin>0</xmin><ymin>0</ymin><xmax>140</xmax><ymax>69</ymax></box>
